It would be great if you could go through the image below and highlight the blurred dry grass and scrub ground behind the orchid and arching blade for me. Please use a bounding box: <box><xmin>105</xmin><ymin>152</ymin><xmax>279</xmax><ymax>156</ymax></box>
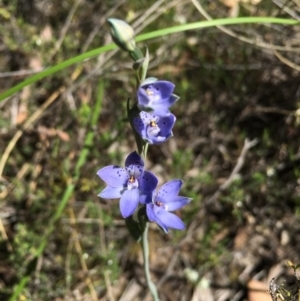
<box><xmin>0</xmin><ymin>0</ymin><xmax>300</xmax><ymax>301</ymax></box>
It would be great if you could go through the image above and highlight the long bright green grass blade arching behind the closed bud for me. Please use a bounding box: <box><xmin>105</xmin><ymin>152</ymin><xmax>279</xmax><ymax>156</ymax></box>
<box><xmin>0</xmin><ymin>17</ymin><xmax>299</xmax><ymax>101</ymax></box>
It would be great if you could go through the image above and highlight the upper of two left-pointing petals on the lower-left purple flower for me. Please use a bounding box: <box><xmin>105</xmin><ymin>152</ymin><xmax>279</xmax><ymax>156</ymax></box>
<box><xmin>97</xmin><ymin>165</ymin><xmax>129</xmax><ymax>187</ymax></box>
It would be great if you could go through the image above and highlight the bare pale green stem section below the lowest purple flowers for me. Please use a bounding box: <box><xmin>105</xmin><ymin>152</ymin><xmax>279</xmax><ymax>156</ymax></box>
<box><xmin>141</xmin><ymin>222</ymin><xmax>159</xmax><ymax>301</ymax></box>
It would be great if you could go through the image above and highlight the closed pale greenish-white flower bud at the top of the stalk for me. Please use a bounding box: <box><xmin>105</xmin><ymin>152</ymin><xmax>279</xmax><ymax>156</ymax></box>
<box><xmin>107</xmin><ymin>18</ymin><xmax>136</xmax><ymax>52</ymax></box>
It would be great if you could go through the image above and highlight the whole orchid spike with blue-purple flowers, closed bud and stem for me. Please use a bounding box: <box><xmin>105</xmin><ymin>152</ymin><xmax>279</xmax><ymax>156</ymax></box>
<box><xmin>97</xmin><ymin>19</ymin><xmax>191</xmax><ymax>301</ymax></box>
